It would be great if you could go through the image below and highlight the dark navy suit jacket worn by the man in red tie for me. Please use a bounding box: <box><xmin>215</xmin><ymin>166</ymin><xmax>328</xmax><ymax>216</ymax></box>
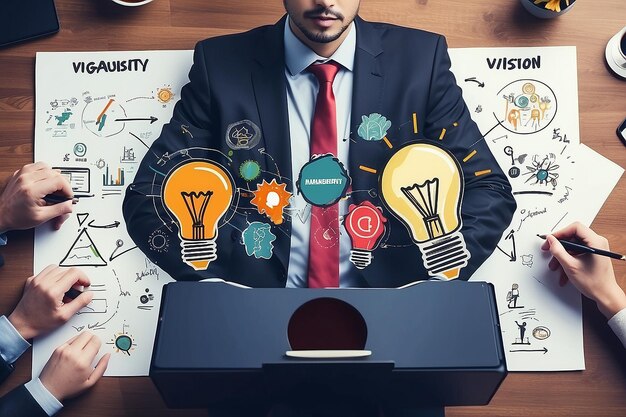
<box><xmin>123</xmin><ymin>18</ymin><xmax>515</xmax><ymax>287</ymax></box>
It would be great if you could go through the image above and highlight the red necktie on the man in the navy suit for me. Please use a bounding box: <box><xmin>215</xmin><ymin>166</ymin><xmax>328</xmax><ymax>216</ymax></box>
<box><xmin>308</xmin><ymin>61</ymin><xmax>340</xmax><ymax>288</ymax></box>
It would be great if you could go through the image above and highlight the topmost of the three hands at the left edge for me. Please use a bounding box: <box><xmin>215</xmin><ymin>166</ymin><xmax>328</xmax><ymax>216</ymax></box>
<box><xmin>0</xmin><ymin>162</ymin><xmax>74</xmax><ymax>233</ymax></box>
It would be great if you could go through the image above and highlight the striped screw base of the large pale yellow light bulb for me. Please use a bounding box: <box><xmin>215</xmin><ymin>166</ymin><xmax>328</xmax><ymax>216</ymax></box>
<box><xmin>418</xmin><ymin>232</ymin><xmax>470</xmax><ymax>279</ymax></box>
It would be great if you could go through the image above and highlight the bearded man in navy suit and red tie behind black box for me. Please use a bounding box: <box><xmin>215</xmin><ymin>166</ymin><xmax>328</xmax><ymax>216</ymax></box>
<box><xmin>123</xmin><ymin>0</ymin><xmax>515</xmax><ymax>287</ymax></box>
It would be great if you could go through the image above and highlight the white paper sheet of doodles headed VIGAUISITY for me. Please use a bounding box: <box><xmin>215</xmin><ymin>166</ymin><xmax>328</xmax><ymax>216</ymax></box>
<box><xmin>33</xmin><ymin>51</ymin><xmax>192</xmax><ymax>375</ymax></box>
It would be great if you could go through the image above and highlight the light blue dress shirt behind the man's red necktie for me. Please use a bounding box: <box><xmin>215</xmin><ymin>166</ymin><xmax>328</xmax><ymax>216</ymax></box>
<box><xmin>284</xmin><ymin>19</ymin><xmax>362</xmax><ymax>288</ymax></box>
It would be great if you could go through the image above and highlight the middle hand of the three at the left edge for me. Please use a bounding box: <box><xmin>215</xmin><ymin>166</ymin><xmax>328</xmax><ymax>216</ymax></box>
<box><xmin>8</xmin><ymin>265</ymin><xmax>93</xmax><ymax>339</ymax></box>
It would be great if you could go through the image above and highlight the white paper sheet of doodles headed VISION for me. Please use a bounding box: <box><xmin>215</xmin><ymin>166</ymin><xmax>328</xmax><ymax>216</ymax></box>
<box><xmin>450</xmin><ymin>47</ymin><xmax>584</xmax><ymax>371</ymax></box>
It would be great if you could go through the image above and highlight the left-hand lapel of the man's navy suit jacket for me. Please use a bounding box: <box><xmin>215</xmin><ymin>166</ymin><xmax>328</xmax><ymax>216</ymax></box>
<box><xmin>252</xmin><ymin>17</ymin><xmax>294</xmax><ymax>275</ymax></box>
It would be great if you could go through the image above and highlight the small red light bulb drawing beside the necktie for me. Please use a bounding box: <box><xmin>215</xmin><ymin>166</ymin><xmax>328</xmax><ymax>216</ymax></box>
<box><xmin>344</xmin><ymin>201</ymin><xmax>387</xmax><ymax>269</ymax></box>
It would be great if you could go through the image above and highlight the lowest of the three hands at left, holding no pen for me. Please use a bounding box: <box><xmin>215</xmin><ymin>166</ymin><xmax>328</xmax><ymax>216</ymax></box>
<box><xmin>39</xmin><ymin>332</ymin><xmax>111</xmax><ymax>401</ymax></box>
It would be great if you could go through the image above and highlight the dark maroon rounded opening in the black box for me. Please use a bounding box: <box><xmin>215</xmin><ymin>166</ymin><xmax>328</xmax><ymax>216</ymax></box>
<box><xmin>287</xmin><ymin>297</ymin><xmax>367</xmax><ymax>350</ymax></box>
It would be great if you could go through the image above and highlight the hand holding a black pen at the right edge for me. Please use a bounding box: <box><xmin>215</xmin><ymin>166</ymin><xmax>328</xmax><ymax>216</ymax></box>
<box><xmin>541</xmin><ymin>222</ymin><xmax>626</xmax><ymax>318</ymax></box>
